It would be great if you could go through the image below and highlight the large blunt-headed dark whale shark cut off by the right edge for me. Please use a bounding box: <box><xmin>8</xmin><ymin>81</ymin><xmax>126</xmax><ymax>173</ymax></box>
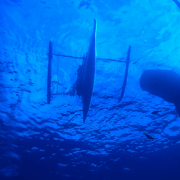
<box><xmin>140</xmin><ymin>70</ymin><xmax>180</xmax><ymax>115</ymax></box>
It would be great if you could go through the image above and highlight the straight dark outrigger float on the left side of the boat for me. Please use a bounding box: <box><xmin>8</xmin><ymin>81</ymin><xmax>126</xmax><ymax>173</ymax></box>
<box><xmin>47</xmin><ymin>41</ymin><xmax>53</xmax><ymax>104</ymax></box>
